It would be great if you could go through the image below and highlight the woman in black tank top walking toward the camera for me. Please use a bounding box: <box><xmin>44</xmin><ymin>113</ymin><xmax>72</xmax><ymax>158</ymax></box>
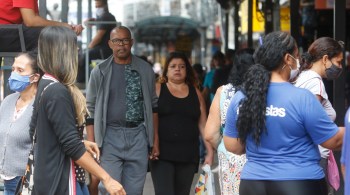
<box><xmin>151</xmin><ymin>52</ymin><xmax>213</xmax><ymax>195</ymax></box>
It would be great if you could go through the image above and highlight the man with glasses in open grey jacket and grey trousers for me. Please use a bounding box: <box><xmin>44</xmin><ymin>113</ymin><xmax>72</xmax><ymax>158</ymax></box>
<box><xmin>87</xmin><ymin>26</ymin><xmax>159</xmax><ymax>195</ymax></box>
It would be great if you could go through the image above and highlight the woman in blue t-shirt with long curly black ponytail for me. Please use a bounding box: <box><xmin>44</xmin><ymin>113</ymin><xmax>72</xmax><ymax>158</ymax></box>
<box><xmin>224</xmin><ymin>32</ymin><xmax>344</xmax><ymax>195</ymax></box>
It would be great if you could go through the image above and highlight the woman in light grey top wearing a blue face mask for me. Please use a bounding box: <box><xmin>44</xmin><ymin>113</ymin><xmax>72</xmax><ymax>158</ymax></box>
<box><xmin>0</xmin><ymin>52</ymin><xmax>40</xmax><ymax>195</ymax></box>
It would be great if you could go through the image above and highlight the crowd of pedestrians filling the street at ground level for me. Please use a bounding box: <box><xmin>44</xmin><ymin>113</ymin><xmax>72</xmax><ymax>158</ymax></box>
<box><xmin>0</xmin><ymin>13</ymin><xmax>350</xmax><ymax>195</ymax></box>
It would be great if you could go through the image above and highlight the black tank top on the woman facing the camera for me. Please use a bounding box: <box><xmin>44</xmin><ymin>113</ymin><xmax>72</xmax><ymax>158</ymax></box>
<box><xmin>158</xmin><ymin>83</ymin><xmax>201</xmax><ymax>163</ymax></box>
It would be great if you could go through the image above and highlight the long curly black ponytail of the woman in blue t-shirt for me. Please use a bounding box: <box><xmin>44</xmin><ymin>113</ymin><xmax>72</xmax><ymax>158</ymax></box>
<box><xmin>237</xmin><ymin>31</ymin><xmax>296</xmax><ymax>145</ymax></box>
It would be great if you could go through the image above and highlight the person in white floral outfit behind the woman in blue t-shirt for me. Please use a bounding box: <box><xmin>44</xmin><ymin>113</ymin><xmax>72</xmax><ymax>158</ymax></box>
<box><xmin>204</xmin><ymin>48</ymin><xmax>254</xmax><ymax>195</ymax></box>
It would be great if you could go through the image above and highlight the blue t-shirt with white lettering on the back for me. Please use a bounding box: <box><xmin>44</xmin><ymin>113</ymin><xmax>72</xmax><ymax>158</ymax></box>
<box><xmin>224</xmin><ymin>82</ymin><xmax>338</xmax><ymax>180</ymax></box>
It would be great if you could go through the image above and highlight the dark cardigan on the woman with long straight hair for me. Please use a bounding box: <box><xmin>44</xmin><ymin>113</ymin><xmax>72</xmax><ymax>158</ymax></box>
<box><xmin>31</xmin><ymin>76</ymin><xmax>86</xmax><ymax>195</ymax></box>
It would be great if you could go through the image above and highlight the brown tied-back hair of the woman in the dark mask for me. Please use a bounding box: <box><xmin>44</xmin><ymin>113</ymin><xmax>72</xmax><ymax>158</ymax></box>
<box><xmin>300</xmin><ymin>37</ymin><xmax>344</xmax><ymax>72</ymax></box>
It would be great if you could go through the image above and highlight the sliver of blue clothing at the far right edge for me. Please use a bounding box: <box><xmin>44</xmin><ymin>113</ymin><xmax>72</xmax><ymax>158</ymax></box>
<box><xmin>340</xmin><ymin>108</ymin><xmax>350</xmax><ymax>195</ymax></box>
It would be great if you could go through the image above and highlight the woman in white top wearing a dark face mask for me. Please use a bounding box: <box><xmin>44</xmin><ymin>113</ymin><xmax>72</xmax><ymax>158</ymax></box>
<box><xmin>294</xmin><ymin>37</ymin><xmax>343</xmax><ymax>195</ymax></box>
